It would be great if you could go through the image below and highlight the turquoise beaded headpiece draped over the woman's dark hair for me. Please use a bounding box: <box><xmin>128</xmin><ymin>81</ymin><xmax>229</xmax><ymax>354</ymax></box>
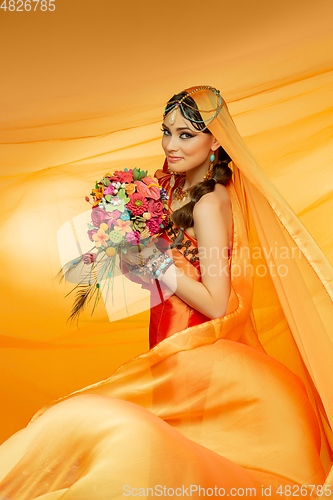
<box><xmin>164</xmin><ymin>85</ymin><xmax>223</xmax><ymax>132</ymax></box>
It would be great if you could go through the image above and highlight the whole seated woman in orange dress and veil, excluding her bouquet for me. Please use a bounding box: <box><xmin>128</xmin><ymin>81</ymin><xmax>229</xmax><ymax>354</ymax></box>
<box><xmin>0</xmin><ymin>86</ymin><xmax>333</xmax><ymax>500</ymax></box>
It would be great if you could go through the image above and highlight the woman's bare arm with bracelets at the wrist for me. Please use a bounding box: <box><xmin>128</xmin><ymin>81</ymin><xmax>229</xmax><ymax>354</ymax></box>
<box><xmin>162</xmin><ymin>186</ymin><xmax>232</xmax><ymax>319</ymax></box>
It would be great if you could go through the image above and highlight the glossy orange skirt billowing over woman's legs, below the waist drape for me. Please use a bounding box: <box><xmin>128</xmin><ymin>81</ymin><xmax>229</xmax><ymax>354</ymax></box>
<box><xmin>0</xmin><ymin>340</ymin><xmax>325</xmax><ymax>500</ymax></box>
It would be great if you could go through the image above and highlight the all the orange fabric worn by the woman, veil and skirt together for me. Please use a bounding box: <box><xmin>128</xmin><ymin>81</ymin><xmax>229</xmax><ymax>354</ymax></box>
<box><xmin>0</xmin><ymin>88</ymin><xmax>333</xmax><ymax>500</ymax></box>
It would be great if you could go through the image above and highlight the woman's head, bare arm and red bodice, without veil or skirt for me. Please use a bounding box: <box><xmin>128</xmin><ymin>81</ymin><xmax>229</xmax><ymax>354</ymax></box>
<box><xmin>126</xmin><ymin>92</ymin><xmax>233</xmax><ymax>348</ymax></box>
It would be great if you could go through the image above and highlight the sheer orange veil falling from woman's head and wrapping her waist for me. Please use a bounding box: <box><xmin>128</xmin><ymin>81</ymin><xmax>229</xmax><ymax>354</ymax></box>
<box><xmin>24</xmin><ymin>88</ymin><xmax>333</xmax><ymax>492</ymax></box>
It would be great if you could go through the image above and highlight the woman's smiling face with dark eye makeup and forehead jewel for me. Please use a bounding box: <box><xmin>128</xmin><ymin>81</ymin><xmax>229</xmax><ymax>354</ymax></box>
<box><xmin>162</xmin><ymin>109</ymin><xmax>219</xmax><ymax>172</ymax></box>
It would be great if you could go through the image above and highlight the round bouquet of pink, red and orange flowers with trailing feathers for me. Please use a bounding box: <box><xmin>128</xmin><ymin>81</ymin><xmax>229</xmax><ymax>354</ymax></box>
<box><xmin>60</xmin><ymin>168</ymin><xmax>169</xmax><ymax>319</ymax></box>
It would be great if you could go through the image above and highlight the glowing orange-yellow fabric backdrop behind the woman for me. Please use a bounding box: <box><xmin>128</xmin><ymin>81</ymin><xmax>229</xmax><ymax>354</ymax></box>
<box><xmin>0</xmin><ymin>0</ymin><xmax>333</xmax><ymax>441</ymax></box>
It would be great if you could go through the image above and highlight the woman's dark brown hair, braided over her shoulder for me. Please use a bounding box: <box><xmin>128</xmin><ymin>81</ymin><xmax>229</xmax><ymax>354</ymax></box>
<box><xmin>164</xmin><ymin>92</ymin><xmax>232</xmax><ymax>248</ymax></box>
